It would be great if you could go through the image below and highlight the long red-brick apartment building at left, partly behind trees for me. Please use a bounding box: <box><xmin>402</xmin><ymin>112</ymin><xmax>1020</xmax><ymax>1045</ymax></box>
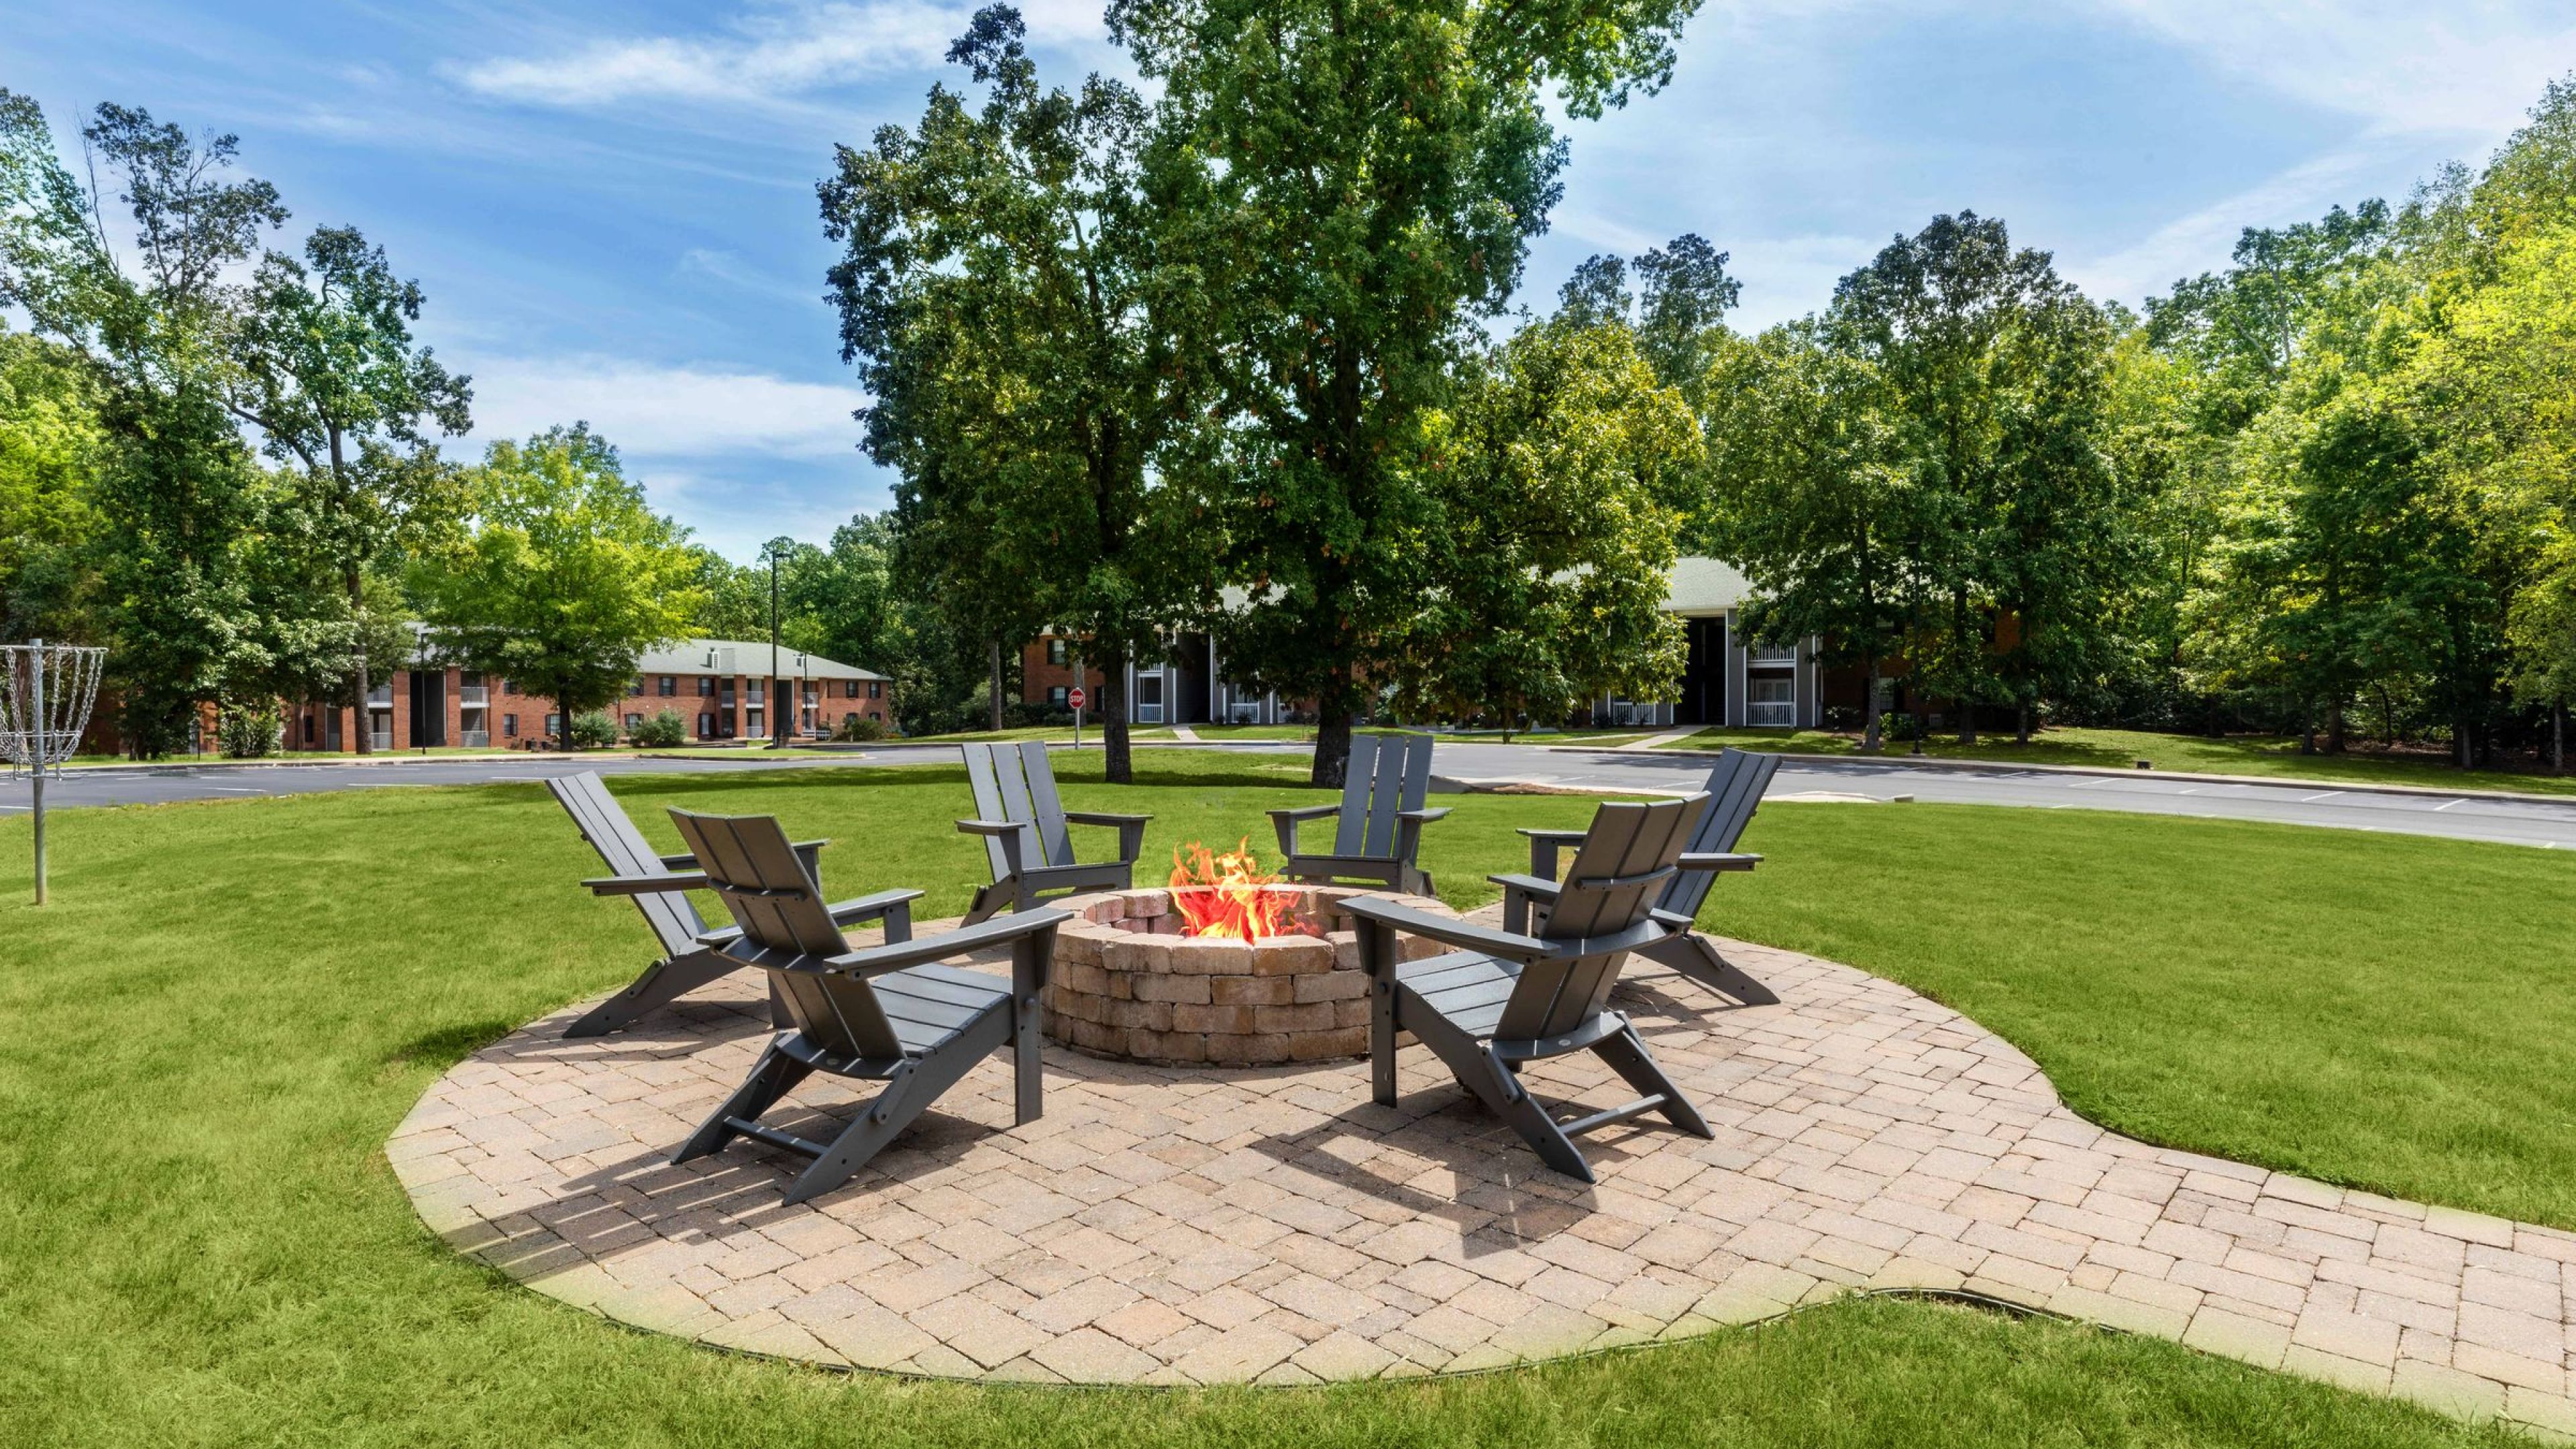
<box><xmin>286</xmin><ymin>639</ymin><xmax>892</xmax><ymax>753</ymax></box>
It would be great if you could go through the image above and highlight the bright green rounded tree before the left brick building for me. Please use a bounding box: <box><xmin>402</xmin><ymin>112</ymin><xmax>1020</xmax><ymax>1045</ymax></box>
<box><xmin>412</xmin><ymin>425</ymin><xmax>703</xmax><ymax>735</ymax></box>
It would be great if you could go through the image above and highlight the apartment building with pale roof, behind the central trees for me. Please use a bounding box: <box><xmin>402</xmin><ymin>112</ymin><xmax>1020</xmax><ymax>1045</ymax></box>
<box><xmin>1020</xmin><ymin>557</ymin><xmax>1823</xmax><ymax>730</ymax></box>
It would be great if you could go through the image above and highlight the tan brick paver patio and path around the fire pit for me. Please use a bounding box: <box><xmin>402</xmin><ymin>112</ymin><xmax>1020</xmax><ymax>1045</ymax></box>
<box><xmin>386</xmin><ymin>912</ymin><xmax>2576</xmax><ymax>1434</ymax></box>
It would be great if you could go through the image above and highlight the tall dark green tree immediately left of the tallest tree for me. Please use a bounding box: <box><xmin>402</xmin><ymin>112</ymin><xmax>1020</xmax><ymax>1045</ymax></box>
<box><xmin>822</xmin><ymin>5</ymin><xmax>1185</xmax><ymax>782</ymax></box>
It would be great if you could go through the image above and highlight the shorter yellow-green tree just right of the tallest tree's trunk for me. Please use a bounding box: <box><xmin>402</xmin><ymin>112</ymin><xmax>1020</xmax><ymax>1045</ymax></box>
<box><xmin>1386</xmin><ymin>322</ymin><xmax>1700</xmax><ymax>730</ymax></box>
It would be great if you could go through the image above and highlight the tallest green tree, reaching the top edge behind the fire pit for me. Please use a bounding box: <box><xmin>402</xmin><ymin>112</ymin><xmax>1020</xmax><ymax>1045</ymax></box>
<box><xmin>1110</xmin><ymin>0</ymin><xmax>1695</xmax><ymax>784</ymax></box>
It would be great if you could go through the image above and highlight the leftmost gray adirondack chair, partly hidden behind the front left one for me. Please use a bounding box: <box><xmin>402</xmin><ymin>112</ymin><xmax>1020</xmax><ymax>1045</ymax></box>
<box><xmin>546</xmin><ymin>771</ymin><xmax>922</xmax><ymax>1036</ymax></box>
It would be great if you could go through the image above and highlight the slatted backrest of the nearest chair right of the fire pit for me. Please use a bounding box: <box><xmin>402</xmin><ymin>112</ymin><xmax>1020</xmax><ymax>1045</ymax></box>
<box><xmin>1494</xmin><ymin>794</ymin><xmax>1708</xmax><ymax>1042</ymax></box>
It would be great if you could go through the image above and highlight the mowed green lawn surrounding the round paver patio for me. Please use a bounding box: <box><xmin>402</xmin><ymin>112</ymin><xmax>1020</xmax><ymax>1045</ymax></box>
<box><xmin>0</xmin><ymin>750</ymin><xmax>2576</xmax><ymax>1446</ymax></box>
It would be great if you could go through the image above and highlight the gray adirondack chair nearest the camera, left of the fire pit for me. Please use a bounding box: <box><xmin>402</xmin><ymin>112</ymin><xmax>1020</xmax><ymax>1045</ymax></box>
<box><xmin>595</xmin><ymin>810</ymin><xmax>1067</xmax><ymax>1204</ymax></box>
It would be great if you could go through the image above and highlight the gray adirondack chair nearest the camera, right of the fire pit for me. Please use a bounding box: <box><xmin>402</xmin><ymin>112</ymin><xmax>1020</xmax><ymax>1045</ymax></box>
<box><xmin>1342</xmin><ymin>794</ymin><xmax>1713</xmax><ymax>1183</ymax></box>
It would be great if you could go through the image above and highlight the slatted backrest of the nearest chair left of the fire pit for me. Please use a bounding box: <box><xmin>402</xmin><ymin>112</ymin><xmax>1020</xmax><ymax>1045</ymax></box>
<box><xmin>669</xmin><ymin>810</ymin><xmax>904</xmax><ymax>1060</ymax></box>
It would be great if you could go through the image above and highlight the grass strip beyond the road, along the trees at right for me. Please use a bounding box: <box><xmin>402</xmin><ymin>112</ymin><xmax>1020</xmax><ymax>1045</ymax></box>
<box><xmin>1662</xmin><ymin>730</ymin><xmax>2576</xmax><ymax>794</ymax></box>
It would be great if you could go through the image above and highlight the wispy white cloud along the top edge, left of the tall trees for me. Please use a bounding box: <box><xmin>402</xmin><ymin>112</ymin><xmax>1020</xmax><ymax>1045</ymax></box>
<box><xmin>456</xmin><ymin>0</ymin><xmax>1100</xmax><ymax>106</ymax></box>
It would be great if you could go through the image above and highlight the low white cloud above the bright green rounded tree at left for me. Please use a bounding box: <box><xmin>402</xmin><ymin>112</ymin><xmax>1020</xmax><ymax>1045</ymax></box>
<box><xmin>469</xmin><ymin>356</ymin><xmax>868</xmax><ymax>459</ymax></box>
